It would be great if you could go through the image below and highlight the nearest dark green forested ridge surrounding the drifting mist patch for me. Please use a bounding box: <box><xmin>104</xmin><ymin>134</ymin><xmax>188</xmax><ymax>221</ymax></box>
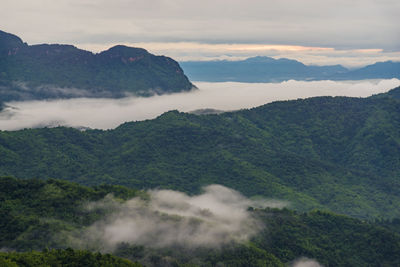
<box><xmin>0</xmin><ymin>177</ymin><xmax>400</xmax><ymax>266</ymax></box>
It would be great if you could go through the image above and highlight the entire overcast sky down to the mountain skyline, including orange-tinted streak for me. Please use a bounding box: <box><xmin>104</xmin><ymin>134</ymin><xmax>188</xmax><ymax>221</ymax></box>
<box><xmin>0</xmin><ymin>0</ymin><xmax>400</xmax><ymax>67</ymax></box>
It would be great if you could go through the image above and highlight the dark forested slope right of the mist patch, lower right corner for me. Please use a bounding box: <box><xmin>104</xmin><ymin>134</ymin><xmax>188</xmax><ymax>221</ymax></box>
<box><xmin>254</xmin><ymin>210</ymin><xmax>400</xmax><ymax>266</ymax></box>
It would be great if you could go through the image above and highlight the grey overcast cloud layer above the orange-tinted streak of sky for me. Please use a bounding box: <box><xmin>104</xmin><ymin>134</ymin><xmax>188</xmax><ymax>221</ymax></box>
<box><xmin>0</xmin><ymin>0</ymin><xmax>400</xmax><ymax>51</ymax></box>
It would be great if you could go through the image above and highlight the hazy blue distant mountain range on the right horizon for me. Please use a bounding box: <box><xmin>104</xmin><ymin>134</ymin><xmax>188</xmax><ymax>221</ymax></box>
<box><xmin>180</xmin><ymin>56</ymin><xmax>400</xmax><ymax>82</ymax></box>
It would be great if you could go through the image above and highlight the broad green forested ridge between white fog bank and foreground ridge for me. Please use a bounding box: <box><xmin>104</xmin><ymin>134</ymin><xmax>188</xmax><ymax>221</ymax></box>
<box><xmin>0</xmin><ymin>87</ymin><xmax>400</xmax><ymax>218</ymax></box>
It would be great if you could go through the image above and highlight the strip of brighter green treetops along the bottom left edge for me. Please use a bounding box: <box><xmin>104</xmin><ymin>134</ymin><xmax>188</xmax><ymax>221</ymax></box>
<box><xmin>0</xmin><ymin>249</ymin><xmax>142</xmax><ymax>267</ymax></box>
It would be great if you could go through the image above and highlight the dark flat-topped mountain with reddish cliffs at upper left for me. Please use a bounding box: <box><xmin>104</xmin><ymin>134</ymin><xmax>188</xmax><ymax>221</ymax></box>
<box><xmin>0</xmin><ymin>31</ymin><xmax>194</xmax><ymax>101</ymax></box>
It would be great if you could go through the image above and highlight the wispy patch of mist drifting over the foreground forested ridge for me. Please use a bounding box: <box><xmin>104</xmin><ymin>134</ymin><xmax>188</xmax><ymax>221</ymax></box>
<box><xmin>66</xmin><ymin>185</ymin><xmax>285</xmax><ymax>251</ymax></box>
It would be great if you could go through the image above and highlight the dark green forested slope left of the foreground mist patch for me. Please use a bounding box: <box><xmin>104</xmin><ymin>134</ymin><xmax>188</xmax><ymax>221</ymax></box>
<box><xmin>0</xmin><ymin>177</ymin><xmax>145</xmax><ymax>250</ymax></box>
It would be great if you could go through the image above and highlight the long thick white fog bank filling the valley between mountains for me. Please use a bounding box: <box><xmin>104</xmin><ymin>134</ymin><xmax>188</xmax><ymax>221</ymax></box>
<box><xmin>0</xmin><ymin>79</ymin><xmax>400</xmax><ymax>130</ymax></box>
